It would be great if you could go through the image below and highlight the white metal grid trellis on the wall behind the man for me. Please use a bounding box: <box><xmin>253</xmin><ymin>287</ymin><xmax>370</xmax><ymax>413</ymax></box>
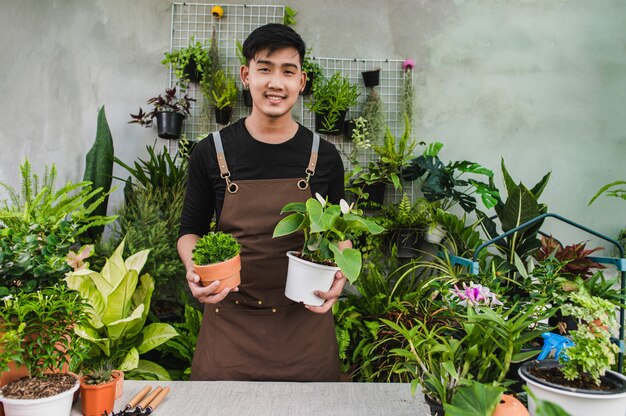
<box><xmin>168</xmin><ymin>3</ymin><xmax>417</xmax><ymax>202</ymax></box>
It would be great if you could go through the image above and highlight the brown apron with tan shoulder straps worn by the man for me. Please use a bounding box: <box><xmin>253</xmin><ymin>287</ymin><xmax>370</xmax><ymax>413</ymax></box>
<box><xmin>191</xmin><ymin>132</ymin><xmax>339</xmax><ymax>381</ymax></box>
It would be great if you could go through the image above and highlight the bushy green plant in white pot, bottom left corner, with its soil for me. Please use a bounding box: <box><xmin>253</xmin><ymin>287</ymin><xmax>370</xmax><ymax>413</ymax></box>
<box><xmin>0</xmin><ymin>286</ymin><xmax>88</xmax><ymax>416</ymax></box>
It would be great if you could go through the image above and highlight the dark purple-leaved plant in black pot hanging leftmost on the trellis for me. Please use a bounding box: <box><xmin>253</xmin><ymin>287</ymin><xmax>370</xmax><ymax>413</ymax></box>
<box><xmin>129</xmin><ymin>87</ymin><xmax>196</xmax><ymax>140</ymax></box>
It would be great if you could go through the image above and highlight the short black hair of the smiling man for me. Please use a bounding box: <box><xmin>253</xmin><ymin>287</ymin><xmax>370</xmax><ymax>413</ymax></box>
<box><xmin>243</xmin><ymin>23</ymin><xmax>306</xmax><ymax>66</ymax></box>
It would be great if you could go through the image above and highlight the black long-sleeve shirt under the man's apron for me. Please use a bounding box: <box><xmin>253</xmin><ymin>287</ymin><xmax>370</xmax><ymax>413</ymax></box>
<box><xmin>179</xmin><ymin>119</ymin><xmax>344</xmax><ymax>236</ymax></box>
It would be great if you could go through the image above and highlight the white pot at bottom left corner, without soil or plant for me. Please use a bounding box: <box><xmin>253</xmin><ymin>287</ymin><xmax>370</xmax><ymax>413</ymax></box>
<box><xmin>0</xmin><ymin>380</ymin><xmax>80</xmax><ymax>416</ymax></box>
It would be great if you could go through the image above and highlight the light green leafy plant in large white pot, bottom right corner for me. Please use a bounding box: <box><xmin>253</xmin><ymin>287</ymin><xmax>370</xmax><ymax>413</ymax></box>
<box><xmin>519</xmin><ymin>287</ymin><xmax>626</xmax><ymax>416</ymax></box>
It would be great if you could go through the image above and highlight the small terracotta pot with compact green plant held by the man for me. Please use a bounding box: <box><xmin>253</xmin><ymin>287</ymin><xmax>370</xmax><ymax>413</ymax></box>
<box><xmin>192</xmin><ymin>231</ymin><xmax>241</xmax><ymax>293</ymax></box>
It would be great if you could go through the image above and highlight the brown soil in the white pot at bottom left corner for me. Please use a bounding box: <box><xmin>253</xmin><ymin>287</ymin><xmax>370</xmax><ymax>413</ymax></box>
<box><xmin>2</xmin><ymin>374</ymin><xmax>77</xmax><ymax>399</ymax></box>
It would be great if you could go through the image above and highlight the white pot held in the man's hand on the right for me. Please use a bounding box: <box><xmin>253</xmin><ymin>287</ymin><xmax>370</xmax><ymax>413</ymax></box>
<box><xmin>285</xmin><ymin>251</ymin><xmax>339</xmax><ymax>306</ymax></box>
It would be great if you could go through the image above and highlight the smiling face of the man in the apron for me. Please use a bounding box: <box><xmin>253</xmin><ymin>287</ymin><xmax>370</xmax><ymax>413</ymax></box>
<box><xmin>240</xmin><ymin>48</ymin><xmax>306</xmax><ymax>122</ymax></box>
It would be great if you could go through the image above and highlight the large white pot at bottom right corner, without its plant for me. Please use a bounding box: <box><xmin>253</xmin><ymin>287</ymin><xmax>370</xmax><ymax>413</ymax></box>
<box><xmin>518</xmin><ymin>361</ymin><xmax>626</xmax><ymax>416</ymax></box>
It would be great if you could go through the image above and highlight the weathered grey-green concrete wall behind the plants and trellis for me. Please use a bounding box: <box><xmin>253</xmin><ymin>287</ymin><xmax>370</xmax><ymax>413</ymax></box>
<box><xmin>0</xmin><ymin>0</ymin><xmax>626</xmax><ymax>250</ymax></box>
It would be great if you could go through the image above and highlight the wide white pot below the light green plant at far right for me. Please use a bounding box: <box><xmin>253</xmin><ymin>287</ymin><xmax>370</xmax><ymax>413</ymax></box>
<box><xmin>519</xmin><ymin>360</ymin><xmax>626</xmax><ymax>416</ymax></box>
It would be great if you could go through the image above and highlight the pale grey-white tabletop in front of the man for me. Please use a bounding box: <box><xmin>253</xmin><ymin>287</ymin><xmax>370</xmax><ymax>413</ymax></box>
<box><xmin>72</xmin><ymin>380</ymin><xmax>430</xmax><ymax>416</ymax></box>
